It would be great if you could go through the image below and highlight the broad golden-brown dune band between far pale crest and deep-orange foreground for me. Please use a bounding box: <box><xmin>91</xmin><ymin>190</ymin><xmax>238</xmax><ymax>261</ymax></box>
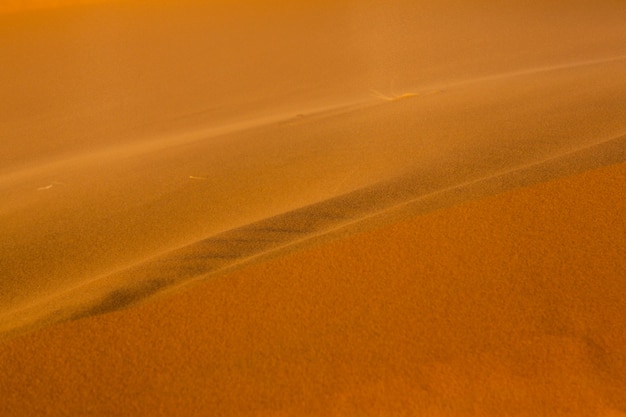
<box><xmin>0</xmin><ymin>49</ymin><xmax>626</xmax><ymax>331</ymax></box>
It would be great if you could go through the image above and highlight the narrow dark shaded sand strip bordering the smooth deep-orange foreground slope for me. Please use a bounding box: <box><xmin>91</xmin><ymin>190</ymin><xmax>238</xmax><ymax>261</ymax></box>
<box><xmin>0</xmin><ymin>135</ymin><xmax>626</xmax><ymax>337</ymax></box>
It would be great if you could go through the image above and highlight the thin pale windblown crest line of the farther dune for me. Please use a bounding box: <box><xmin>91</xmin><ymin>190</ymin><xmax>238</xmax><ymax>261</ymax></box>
<box><xmin>0</xmin><ymin>51</ymin><xmax>626</xmax><ymax>183</ymax></box>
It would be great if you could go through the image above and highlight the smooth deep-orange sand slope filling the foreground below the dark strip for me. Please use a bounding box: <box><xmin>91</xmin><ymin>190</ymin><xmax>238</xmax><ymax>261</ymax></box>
<box><xmin>0</xmin><ymin>164</ymin><xmax>626</xmax><ymax>416</ymax></box>
